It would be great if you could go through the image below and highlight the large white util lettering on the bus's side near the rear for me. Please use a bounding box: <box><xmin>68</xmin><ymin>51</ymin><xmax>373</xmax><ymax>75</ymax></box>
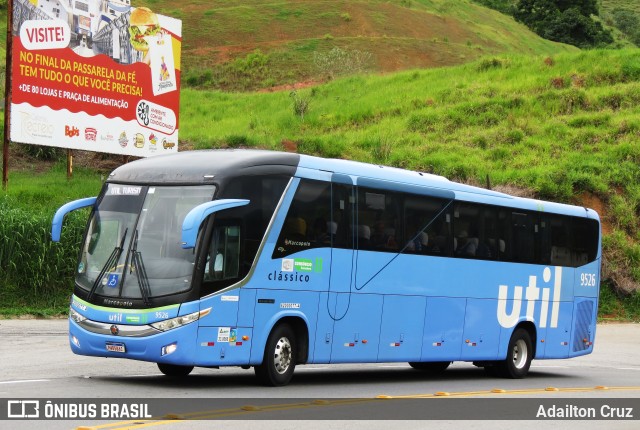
<box><xmin>498</xmin><ymin>267</ymin><xmax>562</xmax><ymax>328</ymax></box>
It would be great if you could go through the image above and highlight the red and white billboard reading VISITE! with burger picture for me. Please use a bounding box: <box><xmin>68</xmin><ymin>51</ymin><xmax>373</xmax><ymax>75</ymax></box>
<box><xmin>10</xmin><ymin>0</ymin><xmax>182</xmax><ymax>157</ymax></box>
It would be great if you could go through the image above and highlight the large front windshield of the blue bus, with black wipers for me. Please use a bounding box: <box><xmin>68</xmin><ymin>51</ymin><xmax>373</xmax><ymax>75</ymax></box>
<box><xmin>76</xmin><ymin>184</ymin><xmax>215</xmax><ymax>298</ymax></box>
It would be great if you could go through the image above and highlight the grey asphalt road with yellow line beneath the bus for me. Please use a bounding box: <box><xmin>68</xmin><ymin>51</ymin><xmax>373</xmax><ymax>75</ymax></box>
<box><xmin>0</xmin><ymin>320</ymin><xmax>640</xmax><ymax>430</ymax></box>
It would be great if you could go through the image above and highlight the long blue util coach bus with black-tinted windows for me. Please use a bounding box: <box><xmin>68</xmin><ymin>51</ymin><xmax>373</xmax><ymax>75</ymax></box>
<box><xmin>52</xmin><ymin>150</ymin><xmax>601</xmax><ymax>386</ymax></box>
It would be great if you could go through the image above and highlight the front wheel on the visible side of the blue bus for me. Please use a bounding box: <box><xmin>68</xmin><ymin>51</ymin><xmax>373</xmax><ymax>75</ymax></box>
<box><xmin>254</xmin><ymin>324</ymin><xmax>298</xmax><ymax>387</ymax></box>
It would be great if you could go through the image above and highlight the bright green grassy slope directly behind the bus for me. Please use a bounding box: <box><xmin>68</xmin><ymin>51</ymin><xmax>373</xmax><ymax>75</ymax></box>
<box><xmin>176</xmin><ymin>49</ymin><xmax>640</xmax><ymax>306</ymax></box>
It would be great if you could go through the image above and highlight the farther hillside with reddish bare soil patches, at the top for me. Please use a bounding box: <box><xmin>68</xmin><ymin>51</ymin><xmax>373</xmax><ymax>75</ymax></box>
<box><xmin>136</xmin><ymin>0</ymin><xmax>575</xmax><ymax>90</ymax></box>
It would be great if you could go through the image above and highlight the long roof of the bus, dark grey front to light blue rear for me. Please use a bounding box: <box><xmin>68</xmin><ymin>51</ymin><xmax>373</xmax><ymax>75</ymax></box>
<box><xmin>108</xmin><ymin>149</ymin><xmax>599</xmax><ymax>219</ymax></box>
